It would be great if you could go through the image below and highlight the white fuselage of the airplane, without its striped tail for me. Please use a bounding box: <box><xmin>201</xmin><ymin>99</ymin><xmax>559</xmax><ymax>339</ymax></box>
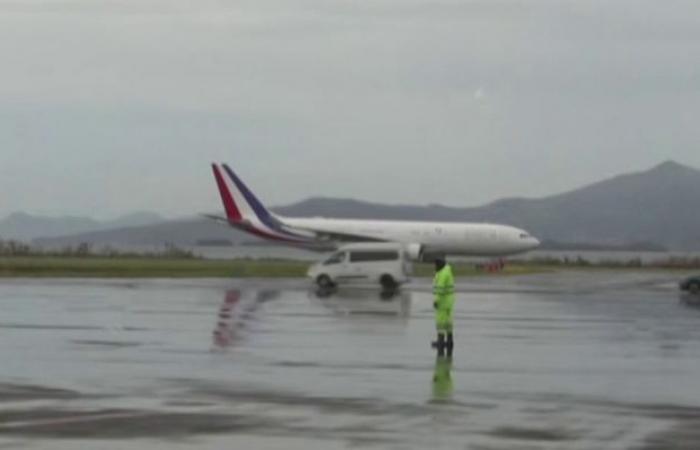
<box><xmin>279</xmin><ymin>217</ymin><xmax>539</xmax><ymax>256</ymax></box>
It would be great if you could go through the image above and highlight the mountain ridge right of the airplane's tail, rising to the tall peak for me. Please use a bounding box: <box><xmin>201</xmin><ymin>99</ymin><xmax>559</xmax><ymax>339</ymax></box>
<box><xmin>278</xmin><ymin>161</ymin><xmax>700</xmax><ymax>249</ymax></box>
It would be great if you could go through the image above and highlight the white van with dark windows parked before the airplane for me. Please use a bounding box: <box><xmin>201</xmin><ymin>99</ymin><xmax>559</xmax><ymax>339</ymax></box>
<box><xmin>308</xmin><ymin>243</ymin><xmax>412</xmax><ymax>289</ymax></box>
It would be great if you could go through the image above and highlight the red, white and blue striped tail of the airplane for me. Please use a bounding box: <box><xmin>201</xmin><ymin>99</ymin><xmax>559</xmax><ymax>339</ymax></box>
<box><xmin>211</xmin><ymin>164</ymin><xmax>315</xmax><ymax>244</ymax></box>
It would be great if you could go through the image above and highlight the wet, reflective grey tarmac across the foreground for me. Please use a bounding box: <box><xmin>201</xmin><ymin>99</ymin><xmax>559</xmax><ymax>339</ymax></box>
<box><xmin>0</xmin><ymin>271</ymin><xmax>700</xmax><ymax>450</ymax></box>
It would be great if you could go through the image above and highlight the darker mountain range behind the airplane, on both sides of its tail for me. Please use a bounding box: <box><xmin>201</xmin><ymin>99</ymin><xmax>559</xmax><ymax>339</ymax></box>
<box><xmin>16</xmin><ymin>161</ymin><xmax>700</xmax><ymax>250</ymax></box>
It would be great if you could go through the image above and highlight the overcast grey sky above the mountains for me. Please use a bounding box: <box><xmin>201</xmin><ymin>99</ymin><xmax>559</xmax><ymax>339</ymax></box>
<box><xmin>0</xmin><ymin>0</ymin><xmax>700</xmax><ymax>218</ymax></box>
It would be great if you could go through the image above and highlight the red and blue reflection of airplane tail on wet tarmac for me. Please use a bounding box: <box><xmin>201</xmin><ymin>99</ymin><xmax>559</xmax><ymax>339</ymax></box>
<box><xmin>212</xmin><ymin>289</ymin><xmax>279</xmax><ymax>350</ymax></box>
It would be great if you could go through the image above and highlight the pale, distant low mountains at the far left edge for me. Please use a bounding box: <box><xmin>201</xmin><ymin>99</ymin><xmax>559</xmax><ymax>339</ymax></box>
<box><xmin>0</xmin><ymin>211</ymin><xmax>165</xmax><ymax>241</ymax></box>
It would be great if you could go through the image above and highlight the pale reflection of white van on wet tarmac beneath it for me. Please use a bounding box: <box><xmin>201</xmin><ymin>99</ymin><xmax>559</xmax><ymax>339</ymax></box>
<box><xmin>310</xmin><ymin>288</ymin><xmax>411</xmax><ymax>318</ymax></box>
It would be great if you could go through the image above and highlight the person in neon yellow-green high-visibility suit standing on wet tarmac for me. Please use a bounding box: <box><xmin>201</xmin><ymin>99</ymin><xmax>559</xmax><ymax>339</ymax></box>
<box><xmin>433</xmin><ymin>257</ymin><xmax>455</xmax><ymax>356</ymax></box>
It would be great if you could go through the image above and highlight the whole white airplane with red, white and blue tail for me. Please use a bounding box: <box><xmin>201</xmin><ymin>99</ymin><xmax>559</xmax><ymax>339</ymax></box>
<box><xmin>206</xmin><ymin>163</ymin><xmax>540</xmax><ymax>260</ymax></box>
